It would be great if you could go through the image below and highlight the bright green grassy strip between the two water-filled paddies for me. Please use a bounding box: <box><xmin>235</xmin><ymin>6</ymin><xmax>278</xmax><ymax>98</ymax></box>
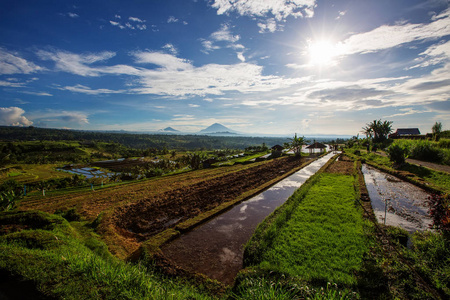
<box><xmin>247</xmin><ymin>173</ymin><xmax>367</xmax><ymax>286</ymax></box>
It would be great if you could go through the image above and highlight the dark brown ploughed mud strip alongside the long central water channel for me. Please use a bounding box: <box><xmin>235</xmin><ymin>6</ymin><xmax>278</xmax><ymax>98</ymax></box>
<box><xmin>114</xmin><ymin>157</ymin><xmax>305</xmax><ymax>241</ymax></box>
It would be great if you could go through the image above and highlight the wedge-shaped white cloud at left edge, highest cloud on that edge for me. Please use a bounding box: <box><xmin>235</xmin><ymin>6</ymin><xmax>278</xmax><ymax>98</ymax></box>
<box><xmin>0</xmin><ymin>47</ymin><xmax>45</xmax><ymax>74</ymax></box>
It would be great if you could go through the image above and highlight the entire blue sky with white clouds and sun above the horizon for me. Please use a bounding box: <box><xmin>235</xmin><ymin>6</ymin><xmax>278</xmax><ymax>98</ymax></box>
<box><xmin>0</xmin><ymin>0</ymin><xmax>450</xmax><ymax>135</ymax></box>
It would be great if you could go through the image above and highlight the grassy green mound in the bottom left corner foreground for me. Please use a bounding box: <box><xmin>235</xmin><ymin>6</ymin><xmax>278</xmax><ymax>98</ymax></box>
<box><xmin>0</xmin><ymin>212</ymin><xmax>213</xmax><ymax>299</ymax></box>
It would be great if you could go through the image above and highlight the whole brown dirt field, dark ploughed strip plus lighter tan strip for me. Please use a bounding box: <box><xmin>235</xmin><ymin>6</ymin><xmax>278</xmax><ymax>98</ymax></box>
<box><xmin>19</xmin><ymin>157</ymin><xmax>305</xmax><ymax>258</ymax></box>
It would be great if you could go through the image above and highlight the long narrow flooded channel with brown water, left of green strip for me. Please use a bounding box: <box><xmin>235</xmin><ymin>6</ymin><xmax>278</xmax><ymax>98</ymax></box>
<box><xmin>161</xmin><ymin>152</ymin><xmax>335</xmax><ymax>284</ymax></box>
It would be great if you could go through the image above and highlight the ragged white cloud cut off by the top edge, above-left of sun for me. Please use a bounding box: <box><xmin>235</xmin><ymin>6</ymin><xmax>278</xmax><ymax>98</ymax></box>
<box><xmin>212</xmin><ymin>0</ymin><xmax>316</xmax><ymax>21</ymax></box>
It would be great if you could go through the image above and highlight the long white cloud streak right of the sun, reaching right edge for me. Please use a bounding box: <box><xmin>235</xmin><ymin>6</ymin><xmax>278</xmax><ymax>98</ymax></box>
<box><xmin>342</xmin><ymin>9</ymin><xmax>450</xmax><ymax>55</ymax></box>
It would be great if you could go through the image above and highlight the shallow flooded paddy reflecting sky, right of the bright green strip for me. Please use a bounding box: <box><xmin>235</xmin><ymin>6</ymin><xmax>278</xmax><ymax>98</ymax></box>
<box><xmin>362</xmin><ymin>165</ymin><xmax>432</xmax><ymax>233</ymax></box>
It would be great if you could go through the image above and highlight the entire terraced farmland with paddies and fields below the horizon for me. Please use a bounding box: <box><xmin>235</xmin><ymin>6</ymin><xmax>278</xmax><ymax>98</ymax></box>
<box><xmin>0</xmin><ymin>123</ymin><xmax>450</xmax><ymax>299</ymax></box>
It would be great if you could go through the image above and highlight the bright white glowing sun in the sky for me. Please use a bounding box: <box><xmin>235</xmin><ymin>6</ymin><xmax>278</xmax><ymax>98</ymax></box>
<box><xmin>308</xmin><ymin>40</ymin><xmax>339</xmax><ymax>67</ymax></box>
